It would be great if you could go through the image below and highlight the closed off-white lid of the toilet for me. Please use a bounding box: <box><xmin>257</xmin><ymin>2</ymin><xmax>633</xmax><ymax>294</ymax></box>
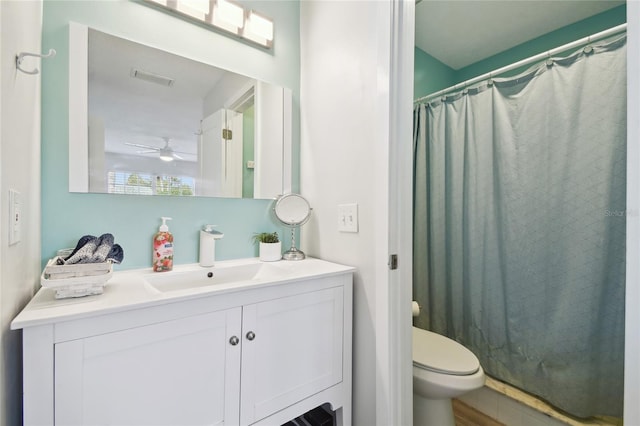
<box><xmin>413</xmin><ymin>327</ymin><xmax>480</xmax><ymax>376</ymax></box>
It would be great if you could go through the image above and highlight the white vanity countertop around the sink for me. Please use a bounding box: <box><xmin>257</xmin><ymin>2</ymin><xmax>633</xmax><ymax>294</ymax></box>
<box><xmin>11</xmin><ymin>258</ymin><xmax>355</xmax><ymax>330</ymax></box>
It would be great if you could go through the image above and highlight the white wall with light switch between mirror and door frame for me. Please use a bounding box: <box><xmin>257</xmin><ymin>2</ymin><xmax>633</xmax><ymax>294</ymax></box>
<box><xmin>300</xmin><ymin>1</ymin><xmax>380</xmax><ymax>425</ymax></box>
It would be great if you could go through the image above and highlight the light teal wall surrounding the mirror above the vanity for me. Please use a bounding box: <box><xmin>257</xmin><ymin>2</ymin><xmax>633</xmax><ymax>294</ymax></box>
<box><xmin>42</xmin><ymin>0</ymin><xmax>300</xmax><ymax>269</ymax></box>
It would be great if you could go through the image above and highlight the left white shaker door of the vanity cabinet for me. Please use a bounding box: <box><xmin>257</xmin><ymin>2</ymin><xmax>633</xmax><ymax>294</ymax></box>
<box><xmin>55</xmin><ymin>308</ymin><xmax>241</xmax><ymax>425</ymax></box>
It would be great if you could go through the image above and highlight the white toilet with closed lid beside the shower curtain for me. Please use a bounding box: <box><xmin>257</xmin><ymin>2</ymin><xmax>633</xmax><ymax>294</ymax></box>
<box><xmin>413</xmin><ymin>327</ymin><xmax>484</xmax><ymax>426</ymax></box>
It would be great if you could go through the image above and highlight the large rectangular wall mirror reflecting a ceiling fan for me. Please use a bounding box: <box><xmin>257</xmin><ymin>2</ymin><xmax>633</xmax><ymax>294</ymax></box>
<box><xmin>69</xmin><ymin>23</ymin><xmax>292</xmax><ymax>199</ymax></box>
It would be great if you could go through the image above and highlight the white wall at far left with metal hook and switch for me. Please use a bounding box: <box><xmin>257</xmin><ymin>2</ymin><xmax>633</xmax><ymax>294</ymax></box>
<box><xmin>0</xmin><ymin>0</ymin><xmax>43</xmax><ymax>425</ymax></box>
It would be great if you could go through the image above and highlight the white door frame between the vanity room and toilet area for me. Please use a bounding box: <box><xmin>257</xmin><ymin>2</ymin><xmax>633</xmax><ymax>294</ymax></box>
<box><xmin>376</xmin><ymin>0</ymin><xmax>415</xmax><ymax>426</ymax></box>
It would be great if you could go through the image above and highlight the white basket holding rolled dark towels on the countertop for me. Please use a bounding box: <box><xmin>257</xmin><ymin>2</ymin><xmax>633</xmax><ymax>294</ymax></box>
<box><xmin>40</xmin><ymin>257</ymin><xmax>113</xmax><ymax>299</ymax></box>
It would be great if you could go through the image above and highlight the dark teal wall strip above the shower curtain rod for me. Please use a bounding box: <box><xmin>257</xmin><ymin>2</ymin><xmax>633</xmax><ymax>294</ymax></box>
<box><xmin>414</xmin><ymin>2</ymin><xmax>627</xmax><ymax>99</ymax></box>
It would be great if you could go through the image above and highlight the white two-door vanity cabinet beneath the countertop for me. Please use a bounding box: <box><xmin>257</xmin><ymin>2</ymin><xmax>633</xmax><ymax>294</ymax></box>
<box><xmin>14</xmin><ymin>260</ymin><xmax>352</xmax><ymax>426</ymax></box>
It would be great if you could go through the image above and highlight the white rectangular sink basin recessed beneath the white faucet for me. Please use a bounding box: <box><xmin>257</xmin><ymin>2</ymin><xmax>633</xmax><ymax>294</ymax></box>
<box><xmin>144</xmin><ymin>263</ymin><xmax>287</xmax><ymax>293</ymax></box>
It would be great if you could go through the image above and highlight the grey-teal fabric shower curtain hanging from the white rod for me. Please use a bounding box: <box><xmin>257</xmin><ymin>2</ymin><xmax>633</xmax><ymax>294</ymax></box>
<box><xmin>413</xmin><ymin>37</ymin><xmax>628</xmax><ymax>417</ymax></box>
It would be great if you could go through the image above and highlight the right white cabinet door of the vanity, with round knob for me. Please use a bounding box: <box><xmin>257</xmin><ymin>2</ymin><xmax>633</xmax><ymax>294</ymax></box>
<box><xmin>240</xmin><ymin>287</ymin><xmax>343</xmax><ymax>425</ymax></box>
